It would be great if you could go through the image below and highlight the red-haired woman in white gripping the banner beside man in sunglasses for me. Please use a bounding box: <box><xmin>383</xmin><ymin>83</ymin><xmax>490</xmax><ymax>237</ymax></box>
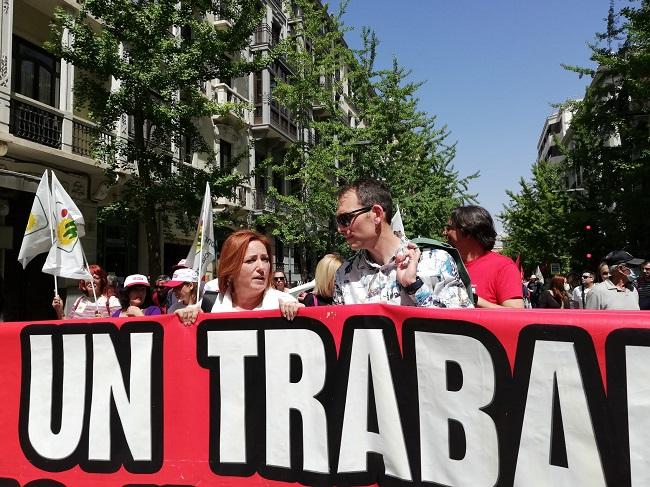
<box><xmin>176</xmin><ymin>230</ymin><xmax>304</xmax><ymax>325</ymax></box>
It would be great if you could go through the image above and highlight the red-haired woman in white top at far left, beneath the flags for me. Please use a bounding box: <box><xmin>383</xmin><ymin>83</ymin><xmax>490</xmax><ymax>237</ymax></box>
<box><xmin>52</xmin><ymin>264</ymin><xmax>122</xmax><ymax>320</ymax></box>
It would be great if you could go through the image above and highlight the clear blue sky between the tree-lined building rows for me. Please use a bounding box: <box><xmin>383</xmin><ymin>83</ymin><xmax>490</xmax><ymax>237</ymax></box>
<box><xmin>330</xmin><ymin>0</ymin><xmax>609</xmax><ymax>233</ymax></box>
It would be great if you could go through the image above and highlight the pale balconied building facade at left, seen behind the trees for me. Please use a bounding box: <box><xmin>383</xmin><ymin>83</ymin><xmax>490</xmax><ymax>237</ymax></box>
<box><xmin>0</xmin><ymin>0</ymin><xmax>359</xmax><ymax>320</ymax></box>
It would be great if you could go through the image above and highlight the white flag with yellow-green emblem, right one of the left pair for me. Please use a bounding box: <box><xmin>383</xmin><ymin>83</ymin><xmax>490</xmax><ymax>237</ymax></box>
<box><xmin>43</xmin><ymin>173</ymin><xmax>91</xmax><ymax>279</ymax></box>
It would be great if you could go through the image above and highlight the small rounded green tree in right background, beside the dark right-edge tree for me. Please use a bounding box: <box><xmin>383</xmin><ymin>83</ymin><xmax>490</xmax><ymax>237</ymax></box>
<box><xmin>499</xmin><ymin>161</ymin><xmax>576</xmax><ymax>272</ymax></box>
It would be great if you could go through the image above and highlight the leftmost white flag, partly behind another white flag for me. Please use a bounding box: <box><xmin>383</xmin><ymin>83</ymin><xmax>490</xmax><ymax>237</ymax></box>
<box><xmin>18</xmin><ymin>171</ymin><xmax>52</xmax><ymax>269</ymax></box>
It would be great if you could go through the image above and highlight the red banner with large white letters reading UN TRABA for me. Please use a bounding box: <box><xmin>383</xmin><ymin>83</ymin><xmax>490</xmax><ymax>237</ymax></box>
<box><xmin>0</xmin><ymin>305</ymin><xmax>650</xmax><ymax>487</ymax></box>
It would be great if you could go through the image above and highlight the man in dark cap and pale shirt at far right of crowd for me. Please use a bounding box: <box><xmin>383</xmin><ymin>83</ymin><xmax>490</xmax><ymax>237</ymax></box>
<box><xmin>586</xmin><ymin>250</ymin><xmax>643</xmax><ymax>310</ymax></box>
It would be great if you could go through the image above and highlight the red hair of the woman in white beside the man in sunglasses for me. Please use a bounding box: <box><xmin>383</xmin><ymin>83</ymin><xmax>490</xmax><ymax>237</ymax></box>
<box><xmin>217</xmin><ymin>230</ymin><xmax>273</xmax><ymax>294</ymax></box>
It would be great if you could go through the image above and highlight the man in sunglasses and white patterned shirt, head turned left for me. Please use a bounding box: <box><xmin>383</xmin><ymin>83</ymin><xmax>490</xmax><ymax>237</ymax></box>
<box><xmin>333</xmin><ymin>179</ymin><xmax>472</xmax><ymax>308</ymax></box>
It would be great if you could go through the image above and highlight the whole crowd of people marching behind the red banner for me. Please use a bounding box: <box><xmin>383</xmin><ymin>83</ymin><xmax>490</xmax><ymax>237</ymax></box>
<box><xmin>52</xmin><ymin>179</ymin><xmax>650</xmax><ymax>325</ymax></box>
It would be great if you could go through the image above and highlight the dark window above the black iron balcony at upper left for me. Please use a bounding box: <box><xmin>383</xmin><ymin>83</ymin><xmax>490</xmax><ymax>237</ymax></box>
<box><xmin>12</xmin><ymin>36</ymin><xmax>61</xmax><ymax>108</ymax></box>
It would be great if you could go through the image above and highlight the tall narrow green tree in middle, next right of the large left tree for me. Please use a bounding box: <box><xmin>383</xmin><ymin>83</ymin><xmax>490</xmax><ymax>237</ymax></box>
<box><xmin>256</xmin><ymin>0</ymin><xmax>354</xmax><ymax>256</ymax></box>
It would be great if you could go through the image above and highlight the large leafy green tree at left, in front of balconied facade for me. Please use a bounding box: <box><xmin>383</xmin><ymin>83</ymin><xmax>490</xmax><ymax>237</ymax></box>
<box><xmin>48</xmin><ymin>0</ymin><xmax>268</xmax><ymax>275</ymax></box>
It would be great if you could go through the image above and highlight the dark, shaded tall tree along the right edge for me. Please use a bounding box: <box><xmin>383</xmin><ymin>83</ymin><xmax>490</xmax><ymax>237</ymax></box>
<box><xmin>566</xmin><ymin>0</ymin><xmax>650</xmax><ymax>264</ymax></box>
